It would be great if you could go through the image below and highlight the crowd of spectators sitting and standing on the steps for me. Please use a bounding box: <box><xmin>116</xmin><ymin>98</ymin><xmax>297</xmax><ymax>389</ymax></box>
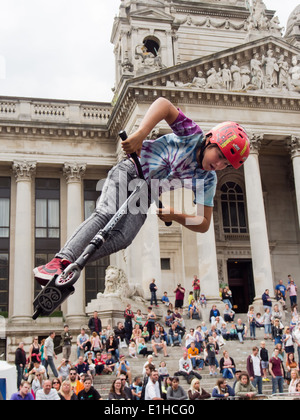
<box><xmin>12</xmin><ymin>276</ymin><xmax>300</xmax><ymax>400</ymax></box>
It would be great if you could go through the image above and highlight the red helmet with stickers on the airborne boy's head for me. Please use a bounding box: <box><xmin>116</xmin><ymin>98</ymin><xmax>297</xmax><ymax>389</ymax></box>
<box><xmin>206</xmin><ymin>121</ymin><xmax>250</xmax><ymax>169</ymax></box>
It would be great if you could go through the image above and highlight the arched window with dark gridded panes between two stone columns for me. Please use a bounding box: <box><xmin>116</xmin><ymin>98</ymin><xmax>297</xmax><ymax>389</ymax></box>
<box><xmin>221</xmin><ymin>182</ymin><xmax>248</xmax><ymax>233</ymax></box>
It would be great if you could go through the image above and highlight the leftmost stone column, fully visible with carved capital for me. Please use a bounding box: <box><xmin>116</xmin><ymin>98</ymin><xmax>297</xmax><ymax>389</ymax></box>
<box><xmin>12</xmin><ymin>161</ymin><xmax>36</xmax><ymax>324</ymax></box>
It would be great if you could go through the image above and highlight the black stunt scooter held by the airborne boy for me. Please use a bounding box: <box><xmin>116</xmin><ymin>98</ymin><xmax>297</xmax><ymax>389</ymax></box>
<box><xmin>32</xmin><ymin>131</ymin><xmax>172</xmax><ymax>320</ymax></box>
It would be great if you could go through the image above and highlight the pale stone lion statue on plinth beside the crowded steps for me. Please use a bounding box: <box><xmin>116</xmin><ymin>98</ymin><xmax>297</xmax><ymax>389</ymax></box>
<box><xmin>97</xmin><ymin>265</ymin><xmax>144</xmax><ymax>301</ymax></box>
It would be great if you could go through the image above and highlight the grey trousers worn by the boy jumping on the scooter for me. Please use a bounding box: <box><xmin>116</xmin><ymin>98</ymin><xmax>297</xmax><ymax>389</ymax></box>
<box><xmin>56</xmin><ymin>160</ymin><xmax>150</xmax><ymax>262</ymax></box>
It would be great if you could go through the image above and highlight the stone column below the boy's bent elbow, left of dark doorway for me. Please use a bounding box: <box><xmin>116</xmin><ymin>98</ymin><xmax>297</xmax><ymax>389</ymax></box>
<box><xmin>197</xmin><ymin>216</ymin><xmax>221</xmax><ymax>313</ymax></box>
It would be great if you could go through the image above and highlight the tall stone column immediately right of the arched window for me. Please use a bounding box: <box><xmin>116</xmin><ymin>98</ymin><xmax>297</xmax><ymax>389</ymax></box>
<box><xmin>244</xmin><ymin>134</ymin><xmax>274</xmax><ymax>304</ymax></box>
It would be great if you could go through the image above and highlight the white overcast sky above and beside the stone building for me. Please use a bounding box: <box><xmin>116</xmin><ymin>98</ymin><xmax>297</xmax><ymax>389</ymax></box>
<box><xmin>0</xmin><ymin>0</ymin><xmax>300</xmax><ymax>102</ymax></box>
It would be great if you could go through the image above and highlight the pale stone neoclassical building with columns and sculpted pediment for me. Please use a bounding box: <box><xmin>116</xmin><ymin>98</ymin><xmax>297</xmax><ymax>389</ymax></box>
<box><xmin>0</xmin><ymin>0</ymin><xmax>300</xmax><ymax>360</ymax></box>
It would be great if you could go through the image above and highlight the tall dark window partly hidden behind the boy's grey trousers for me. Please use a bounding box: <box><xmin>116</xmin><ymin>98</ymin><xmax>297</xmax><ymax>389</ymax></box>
<box><xmin>84</xmin><ymin>180</ymin><xmax>109</xmax><ymax>304</ymax></box>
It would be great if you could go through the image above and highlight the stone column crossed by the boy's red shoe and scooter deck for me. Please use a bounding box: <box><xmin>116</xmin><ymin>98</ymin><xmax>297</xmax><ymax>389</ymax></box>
<box><xmin>63</xmin><ymin>162</ymin><xmax>86</xmax><ymax>327</ymax></box>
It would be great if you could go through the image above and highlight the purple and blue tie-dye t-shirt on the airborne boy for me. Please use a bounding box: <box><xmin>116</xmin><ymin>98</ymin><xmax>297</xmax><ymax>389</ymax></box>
<box><xmin>140</xmin><ymin>110</ymin><xmax>217</xmax><ymax>207</ymax></box>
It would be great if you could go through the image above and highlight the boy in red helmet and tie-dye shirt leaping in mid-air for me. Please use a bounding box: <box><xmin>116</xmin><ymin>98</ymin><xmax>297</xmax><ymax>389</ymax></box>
<box><xmin>33</xmin><ymin>98</ymin><xmax>250</xmax><ymax>285</ymax></box>
